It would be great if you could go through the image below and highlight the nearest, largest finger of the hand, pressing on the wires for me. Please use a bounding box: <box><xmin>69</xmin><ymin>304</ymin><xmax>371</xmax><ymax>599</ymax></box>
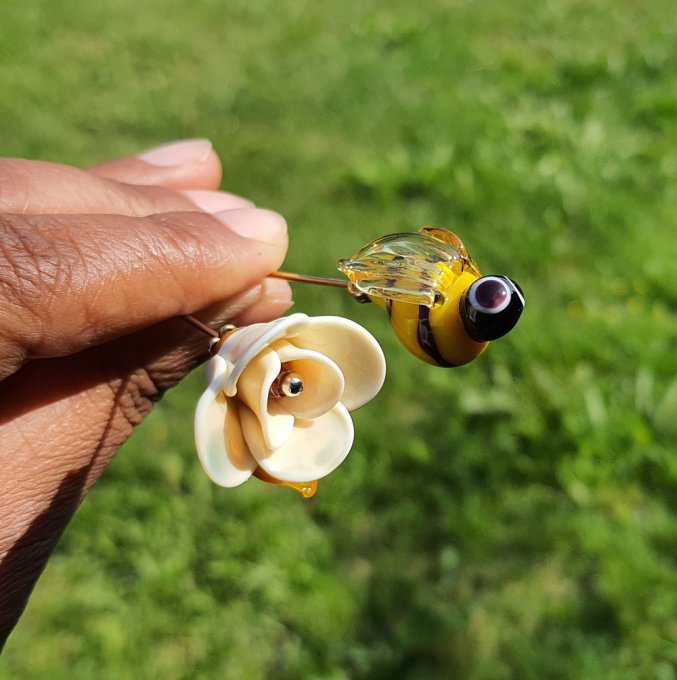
<box><xmin>0</xmin><ymin>208</ymin><xmax>287</xmax><ymax>379</ymax></box>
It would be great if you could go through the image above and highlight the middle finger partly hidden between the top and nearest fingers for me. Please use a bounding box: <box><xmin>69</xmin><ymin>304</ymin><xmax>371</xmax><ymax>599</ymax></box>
<box><xmin>0</xmin><ymin>158</ymin><xmax>253</xmax><ymax>216</ymax></box>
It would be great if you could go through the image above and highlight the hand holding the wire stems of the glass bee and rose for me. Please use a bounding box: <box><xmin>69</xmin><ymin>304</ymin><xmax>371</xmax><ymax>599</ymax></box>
<box><xmin>0</xmin><ymin>140</ymin><xmax>291</xmax><ymax>646</ymax></box>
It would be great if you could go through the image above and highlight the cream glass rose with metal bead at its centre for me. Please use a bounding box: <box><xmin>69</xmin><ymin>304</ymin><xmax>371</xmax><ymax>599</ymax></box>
<box><xmin>195</xmin><ymin>314</ymin><xmax>385</xmax><ymax>496</ymax></box>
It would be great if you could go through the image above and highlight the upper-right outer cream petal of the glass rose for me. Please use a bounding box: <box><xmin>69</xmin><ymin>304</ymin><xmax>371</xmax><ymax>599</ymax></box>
<box><xmin>291</xmin><ymin>316</ymin><xmax>386</xmax><ymax>411</ymax></box>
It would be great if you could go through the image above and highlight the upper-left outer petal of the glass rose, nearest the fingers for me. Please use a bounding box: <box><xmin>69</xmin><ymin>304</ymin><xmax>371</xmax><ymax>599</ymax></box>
<box><xmin>217</xmin><ymin>313</ymin><xmax>308</xmax><ymax>397</ymax></box>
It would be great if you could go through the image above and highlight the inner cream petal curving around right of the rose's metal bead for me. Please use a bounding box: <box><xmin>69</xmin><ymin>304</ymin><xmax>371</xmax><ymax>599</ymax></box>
<box><xmin>269</xmin><ymin>339</ymin><xmax>345</xmax><ymax>420</ymax></box>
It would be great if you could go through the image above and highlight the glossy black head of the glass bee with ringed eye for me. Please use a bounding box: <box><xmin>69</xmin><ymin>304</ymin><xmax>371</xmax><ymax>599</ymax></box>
<box><xmin>459</xmin><ymin>275</ymin><xmax>525</xmax><ymax>342</ymax></box>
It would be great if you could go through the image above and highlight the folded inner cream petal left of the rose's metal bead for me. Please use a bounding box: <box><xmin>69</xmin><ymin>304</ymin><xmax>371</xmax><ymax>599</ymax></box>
<box><xmin>237</xmin><ymin>347</ymin><xmax>294</xmax><ymax>449</ymax></box>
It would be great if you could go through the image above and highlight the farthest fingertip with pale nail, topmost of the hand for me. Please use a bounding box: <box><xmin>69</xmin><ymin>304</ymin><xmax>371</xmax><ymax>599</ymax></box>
<box><xmin>89</xmin><ymin>139</ymin><xmax>221</xmax><ymax>190</ymax></box>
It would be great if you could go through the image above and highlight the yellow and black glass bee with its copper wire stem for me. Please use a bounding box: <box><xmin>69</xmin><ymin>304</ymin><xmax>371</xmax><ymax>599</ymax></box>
<box><xmin>272</xmin><ymin>227</ymin><xmax>525</xmax><ymax>368</ymax></box>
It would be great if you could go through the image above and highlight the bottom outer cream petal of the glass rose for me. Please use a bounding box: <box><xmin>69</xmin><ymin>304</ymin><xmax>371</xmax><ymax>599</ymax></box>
<box><xmin>240</xmin><ymin>403</ymin><xmax>354</xmax><ymax>482</ymax></box>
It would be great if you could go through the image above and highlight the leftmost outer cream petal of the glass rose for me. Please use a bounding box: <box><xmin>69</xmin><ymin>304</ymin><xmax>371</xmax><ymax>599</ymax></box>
<box><xmin>195</xmin><ymin>356</ymin><xmax>257</xmax><ymax>487</ymax></box>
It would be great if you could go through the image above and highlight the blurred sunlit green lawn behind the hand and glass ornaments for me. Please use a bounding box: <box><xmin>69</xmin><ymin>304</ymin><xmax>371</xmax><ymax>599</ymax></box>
<box><xmin>0</xmin><ymin>0</ymin><xmax>677</xmax><ymax>680</ymax></box>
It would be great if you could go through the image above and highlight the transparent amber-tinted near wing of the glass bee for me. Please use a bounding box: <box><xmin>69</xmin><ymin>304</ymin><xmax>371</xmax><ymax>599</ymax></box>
<box><xmin>338</xmin><ymin>233</ymin><xmax>462</xmax><ymax>307</ymax></box>
